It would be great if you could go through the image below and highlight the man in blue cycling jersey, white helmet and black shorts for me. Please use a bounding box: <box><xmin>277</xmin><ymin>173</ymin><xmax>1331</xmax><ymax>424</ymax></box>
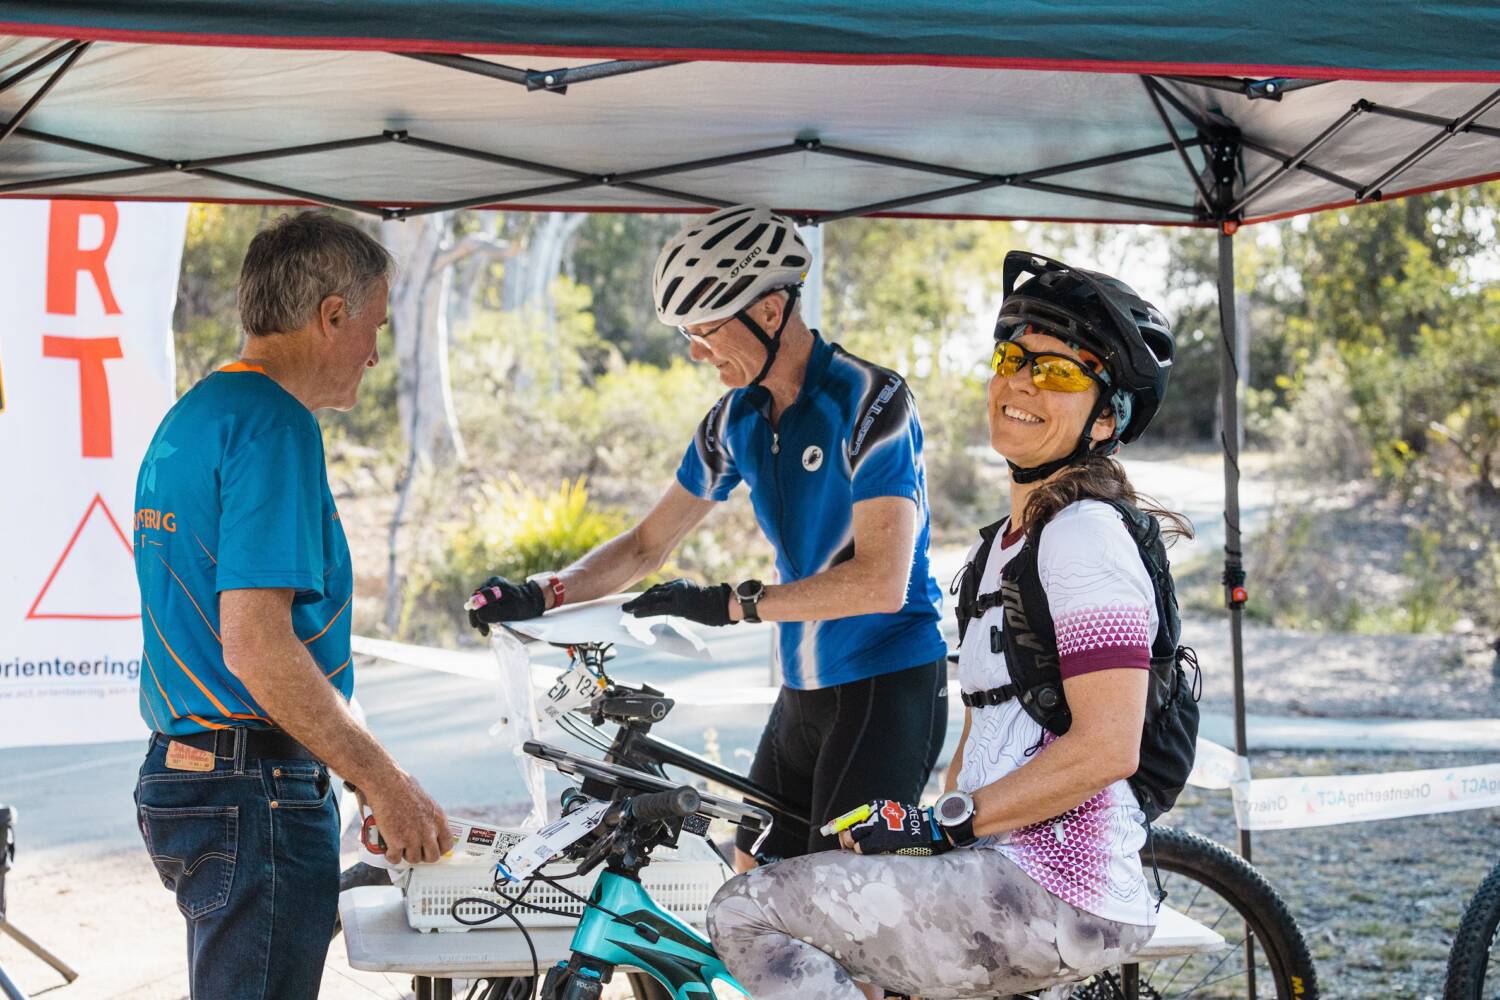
<box><xmin>470</xmin><ymin>205</ymin><xmax>948</xmax><ymax>871</ymax></box>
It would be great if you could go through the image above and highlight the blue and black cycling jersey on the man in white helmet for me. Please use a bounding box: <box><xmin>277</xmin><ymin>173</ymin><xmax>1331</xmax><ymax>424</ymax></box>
<box><xmin>677</xmin><ymin>333</ymin><xmax>947</xmax><ymax>690</ymax></box>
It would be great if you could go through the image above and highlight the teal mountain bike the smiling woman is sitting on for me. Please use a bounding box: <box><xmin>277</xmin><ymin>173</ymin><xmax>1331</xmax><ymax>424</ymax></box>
<box><xmin>343</xmin><ymin>643</ymin><xmax>1319</xmax><ymax>1000</ymax></box>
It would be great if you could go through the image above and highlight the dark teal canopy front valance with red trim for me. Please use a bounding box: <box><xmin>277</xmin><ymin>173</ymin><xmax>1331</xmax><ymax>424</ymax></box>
<box><xmin>0</xmin><ymin>0</ymin><xmax>1500</xmax><ymax>82</ymax></box>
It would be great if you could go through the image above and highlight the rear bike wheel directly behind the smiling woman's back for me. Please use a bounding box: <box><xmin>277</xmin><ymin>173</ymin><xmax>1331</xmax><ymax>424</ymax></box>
<box><xmin>1074</xmin><ymin>828</ymin><xmax>1319</xmax><ymax>1000</ymax></box>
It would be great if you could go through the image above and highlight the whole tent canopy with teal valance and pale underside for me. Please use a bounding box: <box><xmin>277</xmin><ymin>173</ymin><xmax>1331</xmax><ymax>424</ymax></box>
<box><xmin>0</xmin><ymin>0</ymin><xmax>1500</xmax><ymax>225</ymax></box>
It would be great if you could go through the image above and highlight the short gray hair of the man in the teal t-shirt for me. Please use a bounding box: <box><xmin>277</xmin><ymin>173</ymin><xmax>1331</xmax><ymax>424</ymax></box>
<box><xmin>240</xmin><ymin>211</ymin><xmax>395</xmax><ymax>337</ymax></box>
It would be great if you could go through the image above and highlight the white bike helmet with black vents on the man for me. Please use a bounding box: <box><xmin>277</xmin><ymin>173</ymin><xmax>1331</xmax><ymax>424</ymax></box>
<box><xmin>653</xmin><ymin>205</ymin><xmax>813</xmax><ymax>327</ymax></box>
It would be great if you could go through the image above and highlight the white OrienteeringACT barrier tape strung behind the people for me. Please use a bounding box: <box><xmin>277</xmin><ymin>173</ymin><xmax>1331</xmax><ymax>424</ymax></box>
<box><xmin>354</xmin><ymin>636</ymin><xmax>1500</xmax><ymax>831</ymax></box>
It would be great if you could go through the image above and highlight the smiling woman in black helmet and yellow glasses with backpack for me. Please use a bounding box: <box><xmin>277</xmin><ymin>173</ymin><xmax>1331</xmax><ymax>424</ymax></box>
<box><xmin>710</xmin><ymin>252</ymin><xmax>1197</xmax><ymax>1000</ymax></box>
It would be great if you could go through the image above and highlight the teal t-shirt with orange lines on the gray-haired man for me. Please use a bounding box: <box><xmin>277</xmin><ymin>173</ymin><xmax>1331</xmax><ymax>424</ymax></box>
<box><xmin>132</xmin><ymin>363</ymin><xmax>354</xmax><ymax>735</ymax></box>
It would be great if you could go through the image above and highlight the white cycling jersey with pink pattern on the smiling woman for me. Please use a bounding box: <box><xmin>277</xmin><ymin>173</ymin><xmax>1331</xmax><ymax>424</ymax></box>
<box><xmin>959</xmin><ymin>501</ymin><xmax>1157</xmax><ymax>924</ymax></box>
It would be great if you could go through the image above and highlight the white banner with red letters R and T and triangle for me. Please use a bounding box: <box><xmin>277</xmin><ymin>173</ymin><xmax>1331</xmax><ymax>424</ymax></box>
<box><xmin>0</xmin><ymin>201</ymin><xmax>188</xmax><ymax>747</ymax></box>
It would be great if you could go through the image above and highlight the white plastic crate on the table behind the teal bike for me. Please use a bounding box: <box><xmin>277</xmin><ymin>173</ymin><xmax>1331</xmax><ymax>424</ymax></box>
<box><xmin>405</xmin><ymin>837</ymin><xmax>734</xmax><ymax>931</ymax></box>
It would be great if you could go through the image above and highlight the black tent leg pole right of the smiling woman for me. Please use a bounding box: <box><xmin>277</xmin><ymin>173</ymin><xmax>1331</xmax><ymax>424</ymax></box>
<box><xmin>1218</xmin><ymin>229</ymin><xmax>1256</xmax><ymax>999</ymax></box>
